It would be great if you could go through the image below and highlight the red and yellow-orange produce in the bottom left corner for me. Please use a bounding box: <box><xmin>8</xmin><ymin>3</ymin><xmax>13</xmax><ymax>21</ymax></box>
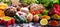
<box><xmin>0</xmin><ymin>16</ymin><xmax>15</xmax><ymax>27</ymax></box>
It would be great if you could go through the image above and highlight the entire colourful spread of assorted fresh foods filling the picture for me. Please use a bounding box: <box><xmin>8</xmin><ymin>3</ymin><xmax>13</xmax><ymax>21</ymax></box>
<box><xmin>0</xmin><ymin>0</ymin><xmax>60</xmax><ymax>27</ymax></box>
